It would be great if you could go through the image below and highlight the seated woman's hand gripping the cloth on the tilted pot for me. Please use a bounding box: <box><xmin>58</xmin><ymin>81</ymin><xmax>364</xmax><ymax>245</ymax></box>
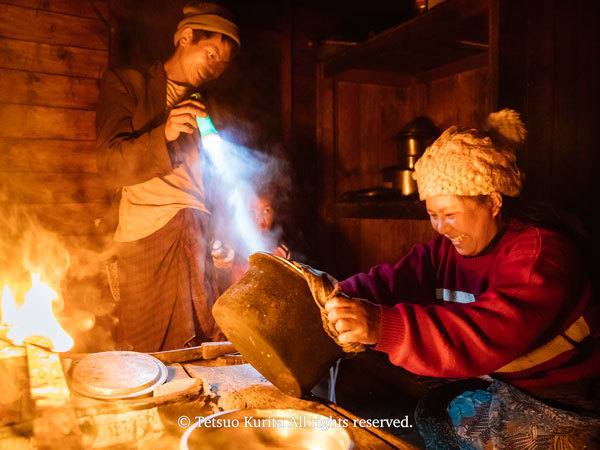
<box><xmin>325</xmin><ymin>297</ymin><xmax>381</xmax><ymax>345</ymax></box>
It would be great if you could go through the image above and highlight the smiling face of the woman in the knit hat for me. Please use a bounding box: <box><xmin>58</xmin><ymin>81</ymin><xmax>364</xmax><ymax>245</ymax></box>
<box><xmin>425</xmin><ymin>192</ymin><xmax>502</xmax><ymax>256</ymax></box>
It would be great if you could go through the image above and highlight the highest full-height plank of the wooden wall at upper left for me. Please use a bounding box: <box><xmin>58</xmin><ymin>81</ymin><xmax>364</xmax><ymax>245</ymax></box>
<box><xmin>0</xmin><ymin>3</ymin><xmax>109</xmax><ymax>50</ymax></box>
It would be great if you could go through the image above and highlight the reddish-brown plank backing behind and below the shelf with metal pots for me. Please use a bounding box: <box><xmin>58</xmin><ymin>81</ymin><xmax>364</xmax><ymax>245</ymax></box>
<box><xmin>317</xmin><ymin>67</ymin><xmax>490</xmax><ymax>277</ymax></box>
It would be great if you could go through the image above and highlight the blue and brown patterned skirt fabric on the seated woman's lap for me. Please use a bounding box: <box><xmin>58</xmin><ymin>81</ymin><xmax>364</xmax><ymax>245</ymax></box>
<box><xmin>415</xmin><ymin>380</ymin><xmax>600</xmax><ymax>450</ymax></box>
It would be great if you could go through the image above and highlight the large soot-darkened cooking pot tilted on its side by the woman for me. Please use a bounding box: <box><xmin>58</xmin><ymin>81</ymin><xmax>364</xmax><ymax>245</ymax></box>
<box><xmin>213</xmin><ymin>253</ymin><xmax>343</xmax><ymax>397</ymax></box>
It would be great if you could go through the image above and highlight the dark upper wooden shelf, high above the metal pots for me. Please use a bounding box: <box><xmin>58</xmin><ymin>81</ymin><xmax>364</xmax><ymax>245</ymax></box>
<box><xmin>324</xmin><ymin>0</ymin><xmax>491</xmax><ymax>82</ymax></box>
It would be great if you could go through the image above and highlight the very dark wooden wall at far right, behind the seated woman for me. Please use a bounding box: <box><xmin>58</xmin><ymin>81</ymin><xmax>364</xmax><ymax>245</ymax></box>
<box><xmin>498</xmin><ymin>0</ymin><xmax>600</xmax><ymax>237</ymax></box>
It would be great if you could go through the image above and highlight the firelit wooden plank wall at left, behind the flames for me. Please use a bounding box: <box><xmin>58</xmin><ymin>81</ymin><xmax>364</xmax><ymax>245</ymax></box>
<box><xmin>0</xmin><ymin>0</ymin><xmax>109</xmax><ymax>349</ymax></box>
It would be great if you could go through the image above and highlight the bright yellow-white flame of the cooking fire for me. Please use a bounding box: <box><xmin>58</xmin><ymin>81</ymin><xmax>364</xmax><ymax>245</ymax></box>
<box><xmin>2</xmin><ymin>273</ymin><xmax>73</xmax><ymax>352</ymax></box>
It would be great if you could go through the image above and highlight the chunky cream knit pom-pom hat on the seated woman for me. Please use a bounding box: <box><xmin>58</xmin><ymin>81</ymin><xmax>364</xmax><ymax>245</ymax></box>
<box><xmin>413</xmin><ymin>109</ymin><xmax>527</xmax><ymax>200</ymax></box>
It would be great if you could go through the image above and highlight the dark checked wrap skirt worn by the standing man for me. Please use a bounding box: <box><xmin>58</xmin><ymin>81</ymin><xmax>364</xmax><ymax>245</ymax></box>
<box><xmin>116</xmin><ymin>209</ymin><xmax>223</xmax><ymax>352</ymax></box>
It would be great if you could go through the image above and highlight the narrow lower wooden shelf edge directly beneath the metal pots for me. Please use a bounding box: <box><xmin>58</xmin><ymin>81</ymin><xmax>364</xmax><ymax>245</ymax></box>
<box><xmin>328</xmin><ymin>198</ymin><xmax>429</xmax><ymax>220</ymax></box>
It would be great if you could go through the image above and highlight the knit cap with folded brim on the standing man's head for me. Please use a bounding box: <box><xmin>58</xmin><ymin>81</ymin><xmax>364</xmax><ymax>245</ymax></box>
<box><xmin>173</xmin><ymin>1</ymin><xmax>240</xmax><ymax>47</ymax></box>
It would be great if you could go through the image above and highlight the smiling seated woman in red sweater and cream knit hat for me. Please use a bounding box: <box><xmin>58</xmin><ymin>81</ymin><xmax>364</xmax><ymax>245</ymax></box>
<box><xmin>326</xmin><ymin>110</ymin><xmax>600</xmax><ymax>448</ymax></box>
